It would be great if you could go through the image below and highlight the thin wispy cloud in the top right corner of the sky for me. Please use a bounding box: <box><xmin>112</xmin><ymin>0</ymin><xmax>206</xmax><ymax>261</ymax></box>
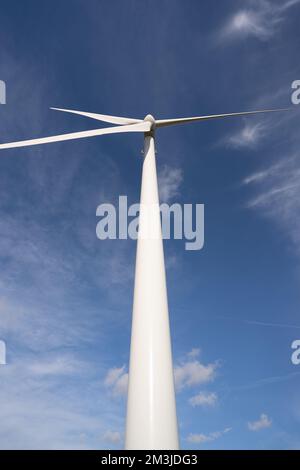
<box><xmin>219</xmin><ymin>0</ymin><xmax>299</xmax><ymax>41</ymax></box>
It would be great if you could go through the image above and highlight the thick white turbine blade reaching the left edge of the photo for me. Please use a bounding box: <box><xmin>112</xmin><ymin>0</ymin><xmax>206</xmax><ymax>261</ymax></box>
<box><xmin>0</xmin><ymin>121</ymin><xmax>151</xmax><ymax>149</ymax></box>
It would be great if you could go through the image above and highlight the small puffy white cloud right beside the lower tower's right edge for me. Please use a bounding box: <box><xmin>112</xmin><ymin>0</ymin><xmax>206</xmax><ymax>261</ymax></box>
<box><xmin>174</xmin><ymin>360</ymin><xmax>218</xmax><ymax>390</ymax></box>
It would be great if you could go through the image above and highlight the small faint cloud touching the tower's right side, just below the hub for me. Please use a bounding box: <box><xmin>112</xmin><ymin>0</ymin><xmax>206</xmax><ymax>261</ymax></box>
<box><xmin>158</xmin><ymin>165</ymin><xmax>183</xmax><ymax>202</ymax></box>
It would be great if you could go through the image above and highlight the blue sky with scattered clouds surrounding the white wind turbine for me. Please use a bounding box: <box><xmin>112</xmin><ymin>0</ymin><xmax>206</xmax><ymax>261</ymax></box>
<box><xmin>0</xmin><ymin>0</ymin><xmax>300</xmax><ymax>449</ymax></box>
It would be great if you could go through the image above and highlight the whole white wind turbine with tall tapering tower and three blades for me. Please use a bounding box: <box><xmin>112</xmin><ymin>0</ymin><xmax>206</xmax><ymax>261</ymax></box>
<box><xmin>0</xmin><ymin>104</ymin><xmax>283</xmax><ymax>450</ymax></box>
